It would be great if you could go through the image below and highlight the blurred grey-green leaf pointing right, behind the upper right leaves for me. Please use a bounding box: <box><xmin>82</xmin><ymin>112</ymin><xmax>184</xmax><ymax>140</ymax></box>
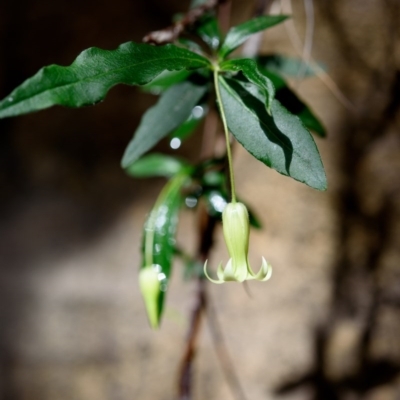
<box><xmin>256</xmin><ymin>54</ymin><xmax>323</xmax><ymax>78</ymax></box>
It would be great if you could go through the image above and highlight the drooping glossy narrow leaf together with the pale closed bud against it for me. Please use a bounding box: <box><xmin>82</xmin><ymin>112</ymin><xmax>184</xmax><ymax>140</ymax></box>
<box><xmin>139</xmin><ymin>173</ymin><xmax>189</xmax><ymax>328</ymax></box>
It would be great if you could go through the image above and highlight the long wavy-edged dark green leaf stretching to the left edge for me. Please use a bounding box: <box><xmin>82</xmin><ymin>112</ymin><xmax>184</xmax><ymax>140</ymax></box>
<box><xmin>0</xmin><ymin>42</ymin><xmax>210</xmax><ymax>118</ymax></box>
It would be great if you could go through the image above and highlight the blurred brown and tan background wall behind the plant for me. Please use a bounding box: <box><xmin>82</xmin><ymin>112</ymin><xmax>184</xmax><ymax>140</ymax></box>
<box><xmin>0</xmin><ymin>0</ymin><xmax>400</xmax><ymax>400</ymax></box>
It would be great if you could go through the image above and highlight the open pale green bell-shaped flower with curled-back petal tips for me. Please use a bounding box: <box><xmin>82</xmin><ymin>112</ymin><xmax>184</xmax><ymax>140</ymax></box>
<box><xmin>204</xmin><ymin>202</ymin><xmax>272</xmax><ymax>283</ymax></box>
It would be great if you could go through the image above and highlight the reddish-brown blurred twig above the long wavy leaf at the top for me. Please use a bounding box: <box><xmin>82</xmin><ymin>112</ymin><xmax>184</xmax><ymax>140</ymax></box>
<box><xmin>143</xmin><ymin>0</ymin><xmax>226</xmax><ymax>45</ymax></box>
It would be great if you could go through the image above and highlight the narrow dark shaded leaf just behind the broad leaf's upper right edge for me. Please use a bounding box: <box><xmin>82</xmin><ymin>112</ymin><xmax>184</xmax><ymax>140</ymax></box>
<box><xmin>260</xmin><ymin>67</ymin><xmax>326</xmax><ymax>137</ymax></box>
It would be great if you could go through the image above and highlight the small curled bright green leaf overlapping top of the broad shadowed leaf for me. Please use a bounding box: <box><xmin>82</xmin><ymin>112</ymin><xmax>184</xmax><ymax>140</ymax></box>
<box><xmin>220</xmin><ymin>58</ymin><xmax>275</xmax><ymax>111</ymax></box>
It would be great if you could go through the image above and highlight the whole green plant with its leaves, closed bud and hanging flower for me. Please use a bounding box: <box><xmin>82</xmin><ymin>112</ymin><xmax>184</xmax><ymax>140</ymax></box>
<box><xmin>0</xmin><ymin>2</ymin><xmax>327</xmax><ymax>396</ymax></box>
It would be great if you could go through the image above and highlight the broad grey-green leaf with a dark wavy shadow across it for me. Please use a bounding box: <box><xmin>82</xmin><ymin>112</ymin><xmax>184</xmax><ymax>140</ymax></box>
<box><xmin>219</xmin><ymin>77</ymin><xmax>327</xmax><ymax>190</ymax></box>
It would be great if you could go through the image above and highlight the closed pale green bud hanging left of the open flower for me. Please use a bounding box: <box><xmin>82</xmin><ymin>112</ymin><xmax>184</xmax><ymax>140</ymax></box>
<box><xmin>139</xmin><ymin>265</ymin><xmax>161</xmax><ymax>328</ymax></box>
